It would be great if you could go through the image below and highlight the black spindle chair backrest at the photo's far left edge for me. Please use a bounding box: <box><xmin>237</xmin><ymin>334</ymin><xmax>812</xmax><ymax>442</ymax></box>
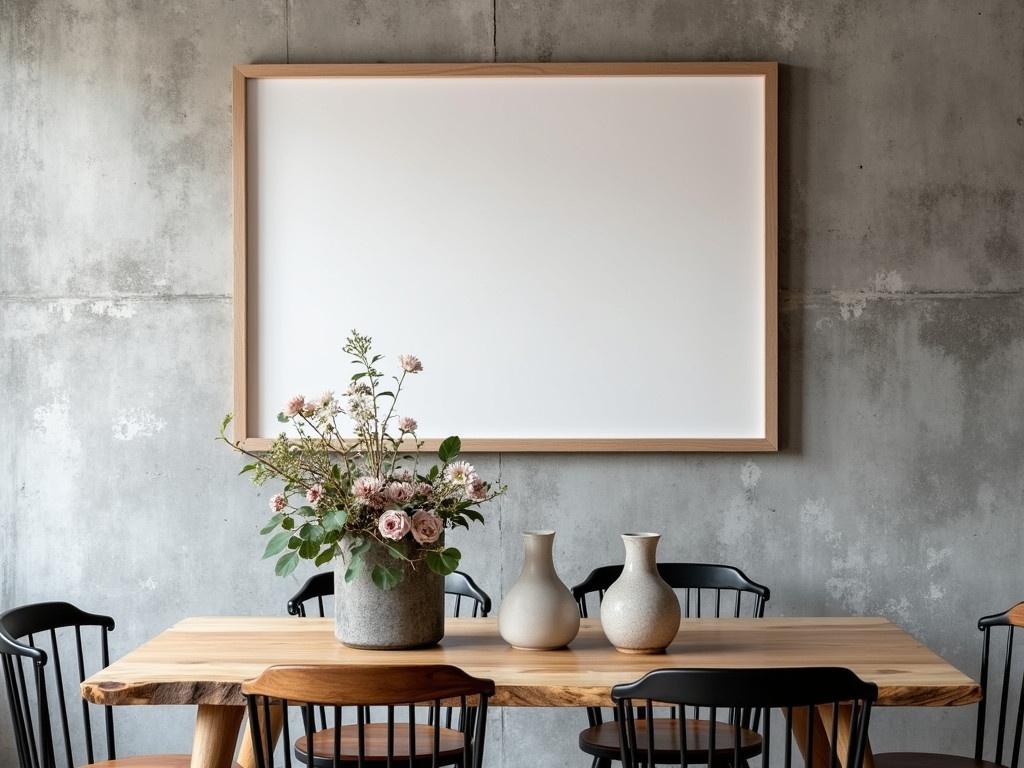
<box><xmin>0</xmin><ymin>602</ymin><xmax>117</xmax><ymax>768</ymax></box>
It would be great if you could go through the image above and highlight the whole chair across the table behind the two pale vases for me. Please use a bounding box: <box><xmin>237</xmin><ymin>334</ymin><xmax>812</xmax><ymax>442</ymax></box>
<box><xmin>572</xmin><ymin>562</ymin><xmax>771</xmax><ymax>768</ymax></box>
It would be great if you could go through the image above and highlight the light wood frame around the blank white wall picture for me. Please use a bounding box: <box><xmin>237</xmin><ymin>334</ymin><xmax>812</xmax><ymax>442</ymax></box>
<box><xmin>231</xmin><ymin>61</ymin><xmax>779</xmax><ymax>453</ymax></box>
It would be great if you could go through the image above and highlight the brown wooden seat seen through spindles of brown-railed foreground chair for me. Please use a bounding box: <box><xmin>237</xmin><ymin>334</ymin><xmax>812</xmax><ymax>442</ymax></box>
<box><xmin>295</xmin><ymin>723</ymin><xmax>465</xmax><ymax>768</ymax></box>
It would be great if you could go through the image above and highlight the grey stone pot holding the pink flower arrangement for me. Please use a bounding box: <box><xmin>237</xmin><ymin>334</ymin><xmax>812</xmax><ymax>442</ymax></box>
<box><xmin>334</xmin><ymin>547</ymin><xmax>444</xmax><ymax>650</ymax></box>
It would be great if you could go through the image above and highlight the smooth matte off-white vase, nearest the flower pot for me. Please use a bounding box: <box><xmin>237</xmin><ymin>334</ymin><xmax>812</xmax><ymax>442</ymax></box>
<box><xmin>498</xmin><ymin>530</ymin><xmax>580</xmax><ymax>650</ymax></box>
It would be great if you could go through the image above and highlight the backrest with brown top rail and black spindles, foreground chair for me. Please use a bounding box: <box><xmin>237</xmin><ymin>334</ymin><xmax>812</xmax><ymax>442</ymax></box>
<box><xmin>242</xmin><ymin>665</ymin><xmax>495</xmax><ymax>768</ymax></box>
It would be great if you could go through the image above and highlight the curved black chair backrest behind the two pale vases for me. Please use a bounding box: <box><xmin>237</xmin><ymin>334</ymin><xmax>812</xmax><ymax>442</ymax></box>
<box><xmin>572</xmin><ymin>562</ymin><xmax>771</xmax><ymax>618</ymax></box>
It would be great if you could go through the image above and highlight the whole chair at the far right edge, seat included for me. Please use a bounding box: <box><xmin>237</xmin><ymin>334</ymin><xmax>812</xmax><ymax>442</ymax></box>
<box><xmin>874</xmin><ymin>602</ymin><xmax>1024</xmax><ymax>768</ymax></box>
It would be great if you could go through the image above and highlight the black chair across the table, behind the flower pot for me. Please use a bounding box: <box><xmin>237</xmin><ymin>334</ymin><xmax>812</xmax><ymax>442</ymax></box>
<box><xmin>288</xmin><ymin>570</ymin><xmax>490</xmax><ymax>766</ymax></box>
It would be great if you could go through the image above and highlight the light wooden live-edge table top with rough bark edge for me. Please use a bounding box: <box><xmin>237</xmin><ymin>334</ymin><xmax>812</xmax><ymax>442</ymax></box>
<box><xmin>82</xmin><ymin>616</ymin><xmax>981</xmax><ymax>707</ymax></box>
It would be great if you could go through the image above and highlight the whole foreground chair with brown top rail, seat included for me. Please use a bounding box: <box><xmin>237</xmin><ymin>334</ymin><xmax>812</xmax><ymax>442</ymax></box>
<box><xmin>242</xmin><ymin>665</ymin><xmax>495</xmax><ymax>768</ymax></box>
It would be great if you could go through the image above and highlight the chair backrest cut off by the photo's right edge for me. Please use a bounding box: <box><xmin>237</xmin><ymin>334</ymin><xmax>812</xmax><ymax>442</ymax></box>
<box><xmin>974</xmin><ymin>602</ymin><xmax>1024</xmax><ymax>768</ymax></box>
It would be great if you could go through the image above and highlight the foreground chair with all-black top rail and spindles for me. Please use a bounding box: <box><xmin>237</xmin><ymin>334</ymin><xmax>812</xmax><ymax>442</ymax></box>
<box><xmin>611</xmin><ymin>667</ymin><xmax>879</xmax><ymax>768</ymax></box>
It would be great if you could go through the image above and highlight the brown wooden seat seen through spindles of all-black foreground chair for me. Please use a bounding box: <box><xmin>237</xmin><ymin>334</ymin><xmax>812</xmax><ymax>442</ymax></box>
<box><xmin>580</xmin><ymin>718</ymin><xmax>765</xmax><ymax>768</ymax></box>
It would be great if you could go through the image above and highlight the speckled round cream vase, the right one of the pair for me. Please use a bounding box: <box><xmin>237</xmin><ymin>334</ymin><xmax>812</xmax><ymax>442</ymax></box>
<box><xmin>601</xmin><ymin>534</ymin><xmax>680</xmax><ymax>653</ymax></box>
